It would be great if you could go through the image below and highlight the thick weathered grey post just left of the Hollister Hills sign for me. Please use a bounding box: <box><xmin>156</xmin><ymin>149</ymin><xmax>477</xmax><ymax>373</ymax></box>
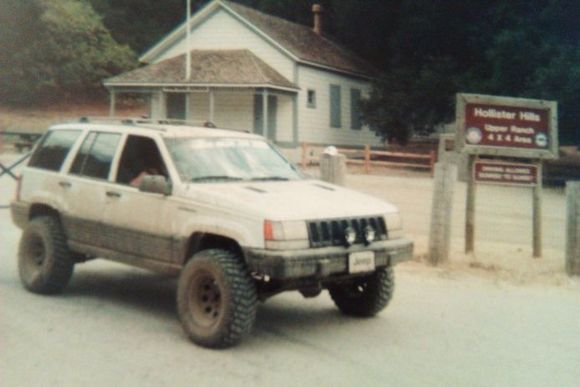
<box><xmin>429</xmin><ymin>162</ymin><xmax>457</xmax><ymax>265</ymax></box>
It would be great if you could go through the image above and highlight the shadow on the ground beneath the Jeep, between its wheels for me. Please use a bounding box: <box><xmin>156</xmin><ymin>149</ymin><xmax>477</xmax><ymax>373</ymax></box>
<box><xmin>60</xmin><ymin>263</ymin><xmax>384</xmax><ymax>345</ymax></box>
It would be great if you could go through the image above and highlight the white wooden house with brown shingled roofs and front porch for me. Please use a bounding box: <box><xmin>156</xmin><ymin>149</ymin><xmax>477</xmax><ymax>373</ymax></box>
<box><xmin>104</xmin><ymin>0</ymin><xmax>381</xmax><ymax>148</ymax></box>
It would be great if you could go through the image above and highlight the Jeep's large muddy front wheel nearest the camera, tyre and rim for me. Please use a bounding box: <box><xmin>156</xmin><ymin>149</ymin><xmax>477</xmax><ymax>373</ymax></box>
<box><xmin>177</xmin><ymin>249</ymin><xmax>257</xmax><ymax>348</ymax></box>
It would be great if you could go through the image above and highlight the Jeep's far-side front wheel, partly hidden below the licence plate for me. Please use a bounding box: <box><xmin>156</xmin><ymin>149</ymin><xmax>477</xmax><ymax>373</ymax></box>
<box><xmin>328</xmin><ymin>267</ymin><xmax>395</xmax><ymax>317</ymax></box>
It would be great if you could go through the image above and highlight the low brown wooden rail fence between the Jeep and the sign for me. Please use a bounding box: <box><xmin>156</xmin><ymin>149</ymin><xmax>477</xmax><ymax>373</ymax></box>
<box><xmin>300</xmin><ymin>143</ymin><xmax>437</xmax><ymax>175</ymax></box>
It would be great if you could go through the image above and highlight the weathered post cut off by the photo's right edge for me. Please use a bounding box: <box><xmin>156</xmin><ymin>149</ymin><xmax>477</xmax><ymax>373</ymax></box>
<box><xmin>566</xmin><ymin>181</ymin><xmax>580</xmax><ymax>276</ymax></box>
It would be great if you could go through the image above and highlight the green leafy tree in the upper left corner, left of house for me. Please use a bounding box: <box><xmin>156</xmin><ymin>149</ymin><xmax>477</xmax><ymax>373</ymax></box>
<box><xmin>0</xmin><ymin>0</ymin><xmax>136</xmax><ymax>103</ymax></box>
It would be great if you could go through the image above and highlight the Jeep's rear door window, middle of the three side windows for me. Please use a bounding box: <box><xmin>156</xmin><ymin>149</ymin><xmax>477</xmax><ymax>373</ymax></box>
<box><xmin>70</xmin><ymin>132</ymin><xmax>121</xmax><ymax>179</ymax></box>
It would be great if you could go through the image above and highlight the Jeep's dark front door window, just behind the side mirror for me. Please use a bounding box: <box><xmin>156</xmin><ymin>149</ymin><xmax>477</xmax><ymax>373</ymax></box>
<box><xmin>116</xmin><ymin>135</ymin><xmax>169</xmax><ymax>187</ymax></box>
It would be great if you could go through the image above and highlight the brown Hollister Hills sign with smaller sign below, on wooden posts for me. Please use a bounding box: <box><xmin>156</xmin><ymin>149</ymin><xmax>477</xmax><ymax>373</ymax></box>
<box><xmin>456</xmin><ymin>94</ymin><xmax>558</xmax><ymax>257</ymax></box>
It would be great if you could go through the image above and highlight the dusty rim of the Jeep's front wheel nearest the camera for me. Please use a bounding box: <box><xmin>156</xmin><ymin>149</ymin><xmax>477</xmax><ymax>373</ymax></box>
<box><xmin>189</xmin><ymin>271</ymin><xmax>223</xmax><ymax>327</ymax></box>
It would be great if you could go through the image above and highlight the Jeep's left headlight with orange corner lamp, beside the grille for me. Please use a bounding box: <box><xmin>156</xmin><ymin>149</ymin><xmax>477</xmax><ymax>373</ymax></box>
<box><xmin>264</xmin><ymin>220</ymin><xmax>310</xmax><ymax>249</ymax></box>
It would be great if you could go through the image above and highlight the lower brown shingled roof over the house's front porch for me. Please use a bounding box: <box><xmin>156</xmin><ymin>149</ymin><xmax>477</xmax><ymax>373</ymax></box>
<box><xmin>104</xmin><ymin>50</ymin><xmax>298</xmax><ymax>89</ymax></box>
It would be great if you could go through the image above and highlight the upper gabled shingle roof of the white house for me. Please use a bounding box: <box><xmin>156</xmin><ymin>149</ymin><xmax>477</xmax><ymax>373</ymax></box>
<box><xmin>141</xmin><ymin>0</ymin><xmax>376</xmax><ymax>77</ymax></box>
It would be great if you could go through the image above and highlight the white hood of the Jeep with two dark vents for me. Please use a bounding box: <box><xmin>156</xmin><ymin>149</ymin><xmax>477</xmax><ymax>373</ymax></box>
<box><xmin>181</xmin><ymin>180</ymin><xmax>398</xmax><ymax>220</ymax></box>
